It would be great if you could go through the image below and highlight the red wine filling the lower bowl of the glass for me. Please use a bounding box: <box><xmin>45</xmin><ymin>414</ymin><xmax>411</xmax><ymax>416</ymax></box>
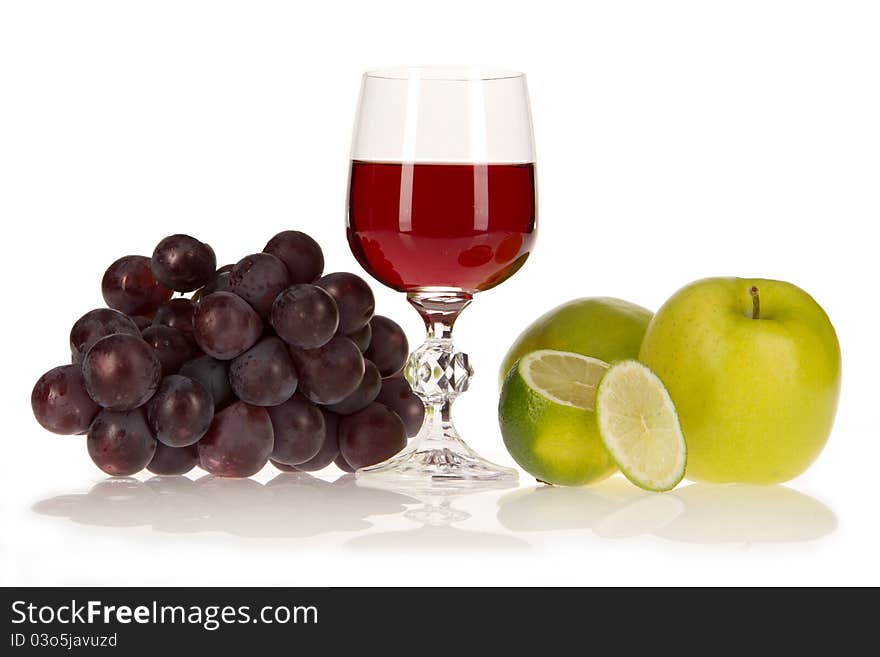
<box><xmin>348</xmin><ymin>160</ymin><xmax>536</xmax><ymax>292</ymax></box>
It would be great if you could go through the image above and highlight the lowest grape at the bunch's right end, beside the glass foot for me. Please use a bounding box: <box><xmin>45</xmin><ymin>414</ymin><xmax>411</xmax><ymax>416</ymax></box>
<box><xmin>339</xmin><ymin>403</ymin><xmax>406</xmax><ymax>469</ymax></box>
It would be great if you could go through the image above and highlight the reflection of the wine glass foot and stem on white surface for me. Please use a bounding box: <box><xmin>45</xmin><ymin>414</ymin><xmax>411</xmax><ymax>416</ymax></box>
<box><xmin>345</xmin><ymin>477</ymin><xmax>529</xmax><ymax>553</ymax></box>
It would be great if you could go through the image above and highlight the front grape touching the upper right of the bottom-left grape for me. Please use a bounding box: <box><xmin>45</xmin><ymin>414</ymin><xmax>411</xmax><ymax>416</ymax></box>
<box><xmin>146</xmin><ymin>374</ymin><xmax>214</xmax><ymax>447</ymax></box>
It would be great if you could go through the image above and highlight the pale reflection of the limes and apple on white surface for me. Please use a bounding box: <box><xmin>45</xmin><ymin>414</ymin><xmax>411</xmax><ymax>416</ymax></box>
<box><xmin>498</xmin><ymin>477</ymin><xmax>837</xmax><ymax>544</ymax></box>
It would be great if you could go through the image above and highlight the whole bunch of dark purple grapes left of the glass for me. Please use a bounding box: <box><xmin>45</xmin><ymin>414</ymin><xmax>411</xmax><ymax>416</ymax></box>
<box><xmin>31</xmin><ymin>231</ymin><xmax>424</xmax><ymax>477</ymax></box>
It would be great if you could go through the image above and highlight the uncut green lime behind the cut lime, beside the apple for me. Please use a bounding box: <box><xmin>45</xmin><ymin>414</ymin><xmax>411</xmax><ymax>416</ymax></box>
<box><xmin>499</xmin><ymin>297</ymin><xmax>652</xmax><ymax>384</ymax></box>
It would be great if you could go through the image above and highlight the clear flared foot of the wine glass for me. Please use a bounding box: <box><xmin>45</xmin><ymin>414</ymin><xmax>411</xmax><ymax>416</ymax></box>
<box><xmin>356</xmin><ymin>439</ymin><xmax>517</xmax><ymax>485</ymax></box>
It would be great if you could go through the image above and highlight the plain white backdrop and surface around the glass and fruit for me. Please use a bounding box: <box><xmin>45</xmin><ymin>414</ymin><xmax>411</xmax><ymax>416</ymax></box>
<box><xmin>0</xmin><ymin>0</ymin><xmax>880</xmax><ymax>585</ymax></box>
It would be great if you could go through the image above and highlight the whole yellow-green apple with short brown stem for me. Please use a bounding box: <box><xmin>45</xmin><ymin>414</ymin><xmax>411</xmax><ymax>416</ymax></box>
<box><xmin>639</xmin><ymin>278</ymin><xmax>840</xmax><ymax>484</ymax></box>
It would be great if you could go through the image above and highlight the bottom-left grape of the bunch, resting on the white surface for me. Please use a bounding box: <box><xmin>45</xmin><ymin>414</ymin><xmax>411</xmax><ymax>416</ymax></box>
<box><xmin>86</xmin><ymin>408</ymin><xmax>156</xmax><ymax>477</ymax></box>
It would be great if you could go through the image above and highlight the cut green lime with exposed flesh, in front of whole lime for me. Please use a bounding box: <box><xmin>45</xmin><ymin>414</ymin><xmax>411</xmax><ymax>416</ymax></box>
<box><xmin>498</xmin><ymin>349</ymin><xmax>615</xmax><ymax>486</ymax></box>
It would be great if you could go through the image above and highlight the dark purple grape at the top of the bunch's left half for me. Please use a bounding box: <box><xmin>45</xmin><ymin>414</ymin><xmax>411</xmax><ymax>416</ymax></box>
<box><xmin>150</xmin><ymin>234</ymin><xmax>217</xmax><ymax>292</ymax></box>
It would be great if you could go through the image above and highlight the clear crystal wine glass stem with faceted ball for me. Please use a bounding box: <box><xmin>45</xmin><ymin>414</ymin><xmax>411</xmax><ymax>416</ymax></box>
<box><xmin>406</xmin><ymin>288</ymin><xmax>473</xmax><ymax>447</ymax></box>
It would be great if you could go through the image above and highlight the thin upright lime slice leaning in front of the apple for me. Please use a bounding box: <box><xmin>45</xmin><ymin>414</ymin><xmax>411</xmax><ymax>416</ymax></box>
<box><xmin>596</xmin><ymin>360</ymin><xmax>687</xmax><ymax>491</ymax></box>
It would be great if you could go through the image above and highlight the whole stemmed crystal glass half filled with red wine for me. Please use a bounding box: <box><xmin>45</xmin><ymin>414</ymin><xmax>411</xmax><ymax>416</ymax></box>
<box><xmin>347</xmin><ymin>67</ymin><xmax>537</xmax><ymax>483</ymax></box>
